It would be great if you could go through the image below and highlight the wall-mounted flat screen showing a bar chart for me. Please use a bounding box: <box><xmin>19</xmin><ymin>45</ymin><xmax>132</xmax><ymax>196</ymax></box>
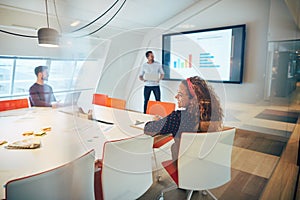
<box><xmin>162</xmin><ymin>24</ymin><xmax>246</xmax><ymax>83</ymax></box>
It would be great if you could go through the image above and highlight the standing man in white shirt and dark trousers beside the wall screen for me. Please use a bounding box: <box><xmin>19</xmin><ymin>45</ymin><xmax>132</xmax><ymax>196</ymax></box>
<box><xmin>139</xmin><ymin>51</ymin><xmax>164</xmax><ymax>113</ymax></box>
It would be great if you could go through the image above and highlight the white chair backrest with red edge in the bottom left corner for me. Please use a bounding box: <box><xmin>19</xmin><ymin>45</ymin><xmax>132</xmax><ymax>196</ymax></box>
<box><xmin>6</xmin><ymin>150</ymin><xmax>95</xmax><ymax>200</ymax></box>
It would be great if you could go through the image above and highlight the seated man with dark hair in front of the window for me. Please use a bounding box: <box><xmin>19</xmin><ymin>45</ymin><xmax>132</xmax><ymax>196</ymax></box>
<box><xmin>29</xmin><ymin>66</ymin><xmax>56</xmax><ymax>107</ymax></box>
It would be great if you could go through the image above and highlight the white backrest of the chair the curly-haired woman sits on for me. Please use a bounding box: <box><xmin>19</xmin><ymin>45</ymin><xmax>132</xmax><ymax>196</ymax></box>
<box><xmin>178</xmin><ymin>128</ymin><xmax>235</xmax><ymax>190</ymax></box>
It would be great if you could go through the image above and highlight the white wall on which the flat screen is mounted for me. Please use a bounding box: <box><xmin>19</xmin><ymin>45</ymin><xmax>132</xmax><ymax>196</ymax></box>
<box><xmin>126</xmin><ymin>0</ymin><xmax>270</xmax><ymax>110</ymax></box>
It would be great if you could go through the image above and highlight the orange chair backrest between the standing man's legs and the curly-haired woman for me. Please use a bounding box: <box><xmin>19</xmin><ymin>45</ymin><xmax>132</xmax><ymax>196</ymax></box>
<box><xmin>146</xmin><ymin>101</ymin><xmax>175</xmax><ymax>117</ymax></box>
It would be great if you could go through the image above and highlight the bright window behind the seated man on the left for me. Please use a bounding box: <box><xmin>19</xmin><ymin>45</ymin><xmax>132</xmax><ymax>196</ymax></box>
<box><xmin>0</xmin><ymin>56</ymin><xmax>97</xmax><ymax>100</ymax></box>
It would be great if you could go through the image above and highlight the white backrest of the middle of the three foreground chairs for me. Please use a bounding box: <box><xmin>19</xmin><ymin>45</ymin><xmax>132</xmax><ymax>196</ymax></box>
<box><xmin>101</xmin><ymin>134</ymin><xmax>153</xmax><ymax>200</ymax></box>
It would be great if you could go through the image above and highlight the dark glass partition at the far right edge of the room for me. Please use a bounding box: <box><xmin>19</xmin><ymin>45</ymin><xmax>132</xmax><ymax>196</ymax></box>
<box><xmin>265</xmin><ymin>40</ymin><xmax>300</xmax><ymax>105</ymax></box>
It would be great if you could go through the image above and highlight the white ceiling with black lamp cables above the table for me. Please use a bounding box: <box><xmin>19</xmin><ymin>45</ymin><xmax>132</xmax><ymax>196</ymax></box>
<box><xmin>0</xmin><ymin>0</ymin><xmax>201</xmax><ymax>37</ymax></box>
